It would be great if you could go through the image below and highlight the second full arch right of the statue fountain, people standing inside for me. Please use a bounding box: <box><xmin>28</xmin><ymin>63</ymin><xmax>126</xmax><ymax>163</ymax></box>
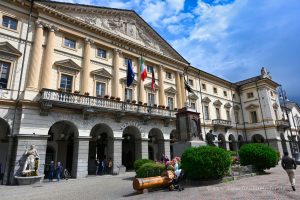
<box><xmin>88</xmin><ymin>123</ymin><xmax>114</xmax><ymax>174</ymax></box>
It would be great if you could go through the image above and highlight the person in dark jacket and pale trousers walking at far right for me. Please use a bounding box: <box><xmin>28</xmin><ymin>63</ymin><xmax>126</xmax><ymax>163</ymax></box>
<box><xmin>281</xmin><ymin>152</ymin><xmax>297</xmax><ymax>191</ymax></box>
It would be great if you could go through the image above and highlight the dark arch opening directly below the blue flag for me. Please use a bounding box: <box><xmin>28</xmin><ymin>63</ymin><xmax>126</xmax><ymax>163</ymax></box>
<box><xmin>122</xmin><ymin>125</ymin><xmax>142</xmax><ymax>170</ymax></box>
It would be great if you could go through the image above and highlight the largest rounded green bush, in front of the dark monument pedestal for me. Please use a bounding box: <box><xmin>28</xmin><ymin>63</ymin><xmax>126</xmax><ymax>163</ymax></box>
<box><xmin>181</xmin><ymin>146</ymin><xmax>231</xmax><ymax>180</ymax></box>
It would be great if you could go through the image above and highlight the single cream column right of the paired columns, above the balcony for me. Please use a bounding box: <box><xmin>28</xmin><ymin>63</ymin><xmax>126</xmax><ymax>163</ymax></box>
<box><xmin>80</xmin><ymin>38</ymin><xmax>93</xmax><ymax>94</ymax></box>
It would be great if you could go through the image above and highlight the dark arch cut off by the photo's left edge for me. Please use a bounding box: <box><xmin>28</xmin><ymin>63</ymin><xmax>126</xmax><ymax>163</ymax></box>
<box><xmin>0</xmin><ymin>118</ymin><xmax>11</xmax><ymax>184</ymax></box>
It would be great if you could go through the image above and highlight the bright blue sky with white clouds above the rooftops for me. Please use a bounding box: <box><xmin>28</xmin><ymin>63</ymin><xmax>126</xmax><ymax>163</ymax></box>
<box><xmin>56</xmin><ymin>0</ymin><xmax>300</xmax><ymax>103</ymax></box>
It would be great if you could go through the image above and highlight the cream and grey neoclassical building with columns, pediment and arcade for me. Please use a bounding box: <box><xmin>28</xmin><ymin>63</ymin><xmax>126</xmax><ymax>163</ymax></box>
<box><xmin>0</xmin><ymin>0</ymin><xmax>300</xmax><ymax>184</ymax></box>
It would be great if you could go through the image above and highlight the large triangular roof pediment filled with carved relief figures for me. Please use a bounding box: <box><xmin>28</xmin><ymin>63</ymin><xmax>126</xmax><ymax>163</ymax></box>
<box><xmin>38</xmin><ymin>1</ymin><xmax>188</xmax><ymax>64</ymax></box>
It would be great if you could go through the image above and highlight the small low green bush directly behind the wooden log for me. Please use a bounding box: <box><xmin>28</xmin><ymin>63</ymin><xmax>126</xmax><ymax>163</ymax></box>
<box><xmin>136</xmin><ymin>163</ymin><xmax>166</xmax><ymax>178</ymax></box>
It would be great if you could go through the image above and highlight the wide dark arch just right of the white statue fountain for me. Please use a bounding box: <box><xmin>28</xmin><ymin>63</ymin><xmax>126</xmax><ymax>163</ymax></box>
<box><xmin>45</xmin><ymin>120</ymin><xmax>79</xmax><ymax>178</ymax></box>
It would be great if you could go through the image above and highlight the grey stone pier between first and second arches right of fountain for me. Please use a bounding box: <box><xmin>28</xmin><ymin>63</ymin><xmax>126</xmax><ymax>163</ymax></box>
<box><xmin>71</xmin><ymin>137</ymin><xmax>90</xmax><ymax>178</ymax></box>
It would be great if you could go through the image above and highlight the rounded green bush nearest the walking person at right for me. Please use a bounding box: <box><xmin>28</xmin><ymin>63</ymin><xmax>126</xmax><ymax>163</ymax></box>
<box><xmin>239</xmin><ymin>144</ymin><xmax>278</xmax><ymax>171</ymax></box>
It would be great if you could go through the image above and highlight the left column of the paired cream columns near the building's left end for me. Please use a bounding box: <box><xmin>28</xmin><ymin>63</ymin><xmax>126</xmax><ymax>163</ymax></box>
<box><xmin>26</xmin><ymin>21</ymin><xmax>43</xmax><ymax>90</ymax></box>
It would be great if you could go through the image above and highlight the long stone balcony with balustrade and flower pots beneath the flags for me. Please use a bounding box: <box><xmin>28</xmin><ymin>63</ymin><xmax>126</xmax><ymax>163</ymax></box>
<box><xmin>40</xmin><ymin>89</ymin><xmax>177</xmax><ymax>121</ymax></box>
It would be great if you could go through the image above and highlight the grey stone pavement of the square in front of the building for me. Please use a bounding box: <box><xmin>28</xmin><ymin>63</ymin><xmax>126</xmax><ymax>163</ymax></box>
<box><xmin>0</xmin><ymin>167</ymin><xmax>300</xmax><ymax>200</ymax></box>
